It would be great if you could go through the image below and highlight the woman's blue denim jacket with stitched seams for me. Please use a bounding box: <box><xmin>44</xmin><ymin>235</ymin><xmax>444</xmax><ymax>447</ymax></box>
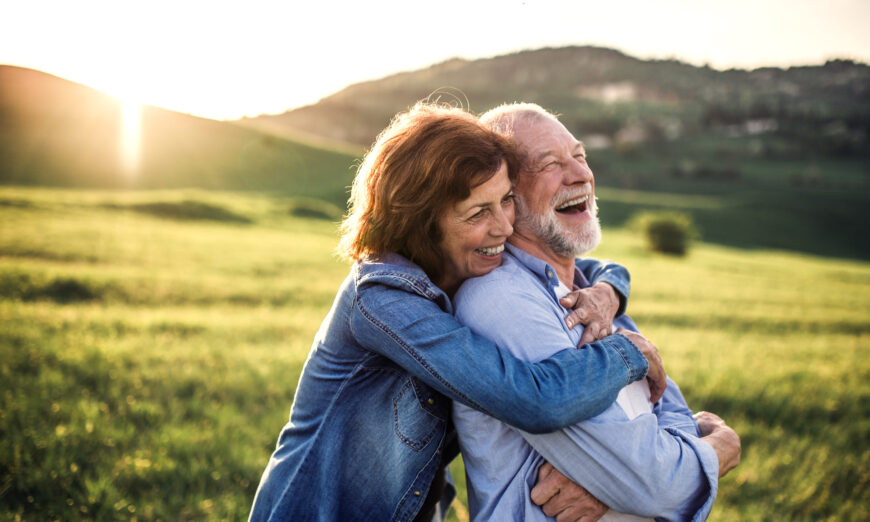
<box><xmin>250</xmin><ymin>254</ymin><xmax>647</xmax><ymax>521</ymax></box>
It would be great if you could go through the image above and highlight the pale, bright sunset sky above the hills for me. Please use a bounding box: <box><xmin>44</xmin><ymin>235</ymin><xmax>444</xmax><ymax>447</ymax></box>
<box><xmin>0</xmin><ymin>0</ymin><xmax>870</xmax><ymax>119</ymax></box>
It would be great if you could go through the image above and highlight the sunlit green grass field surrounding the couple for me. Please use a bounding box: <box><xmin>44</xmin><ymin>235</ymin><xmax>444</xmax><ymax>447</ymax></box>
<box><xmin>0</xmin><ymin>188</ymin><xmax>870</xmax><ymax>521</ymax></box>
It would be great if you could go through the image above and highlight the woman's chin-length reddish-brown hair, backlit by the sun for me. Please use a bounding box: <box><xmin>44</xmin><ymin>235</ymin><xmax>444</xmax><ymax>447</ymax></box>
<box><xmin>338</xmin><ymin>103</ymin><xmax>519</xmax><ymax>280</ymax></box>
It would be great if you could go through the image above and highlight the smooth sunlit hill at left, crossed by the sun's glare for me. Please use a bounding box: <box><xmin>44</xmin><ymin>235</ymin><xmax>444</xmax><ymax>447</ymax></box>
<box><xmin>0</xmin><ymin>66</ymin><xmax>354</xmax><ymax>205</ymax></box>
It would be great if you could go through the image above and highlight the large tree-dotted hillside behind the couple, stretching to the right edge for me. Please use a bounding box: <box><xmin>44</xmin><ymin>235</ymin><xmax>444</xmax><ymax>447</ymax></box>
<box><xmin>239</xmin><ymin>47</ymin><xmax>870</xmax><ymax>259</ymax></box>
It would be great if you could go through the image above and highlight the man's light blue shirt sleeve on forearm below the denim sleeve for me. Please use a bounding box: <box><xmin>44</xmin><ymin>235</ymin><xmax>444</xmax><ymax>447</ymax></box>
<box><xmin>520</xmin><ymin>406</ymin><xmax>719</xmax><ymax>520</ymax></box>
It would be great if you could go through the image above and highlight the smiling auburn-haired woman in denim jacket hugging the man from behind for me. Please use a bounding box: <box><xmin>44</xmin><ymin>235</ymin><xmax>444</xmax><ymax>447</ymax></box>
<box><xmin>250</xmin><ymin>104</ymin><xmax>647</xmax><ymax>521</ymax></box>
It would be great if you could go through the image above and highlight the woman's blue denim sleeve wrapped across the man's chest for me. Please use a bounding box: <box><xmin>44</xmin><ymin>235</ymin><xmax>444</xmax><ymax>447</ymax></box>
<box><xmin>351</xmin><ymin>284</ymin><xmax>648</xmax><ymax>433</ymax></box>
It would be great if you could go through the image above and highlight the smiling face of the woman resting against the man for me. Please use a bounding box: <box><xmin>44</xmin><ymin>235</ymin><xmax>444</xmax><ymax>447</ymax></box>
<box><xmin>438</xmin><ymin>163</ymin><xmax>514</xmax><ymax>294</ymax></box>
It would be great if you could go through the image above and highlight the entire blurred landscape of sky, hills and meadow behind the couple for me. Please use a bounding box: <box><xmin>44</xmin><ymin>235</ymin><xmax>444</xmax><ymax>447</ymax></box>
<box><xmin>0</xmin><ymin>0</ymin><xmax>870</xmax><ymax>520</ymax></box>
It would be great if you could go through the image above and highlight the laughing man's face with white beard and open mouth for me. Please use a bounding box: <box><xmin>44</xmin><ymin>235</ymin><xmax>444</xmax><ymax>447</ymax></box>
<box><xmin>514</xmin><ymin>118</ymin><xmax>601</xmax><ymax>257</ymax></box>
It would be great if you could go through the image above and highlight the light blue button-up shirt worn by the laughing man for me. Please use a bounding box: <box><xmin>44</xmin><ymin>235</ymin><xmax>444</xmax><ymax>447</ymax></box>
<box><xmin>453</xmin><ymin>245</ymin><xmax>719</xmax><ymax>521</ymax></box>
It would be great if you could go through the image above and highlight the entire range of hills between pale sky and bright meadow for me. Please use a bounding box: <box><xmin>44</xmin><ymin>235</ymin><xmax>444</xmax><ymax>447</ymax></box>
<box><xmin>0</xmin><ymin>55</ymin><xmax>870</xmax><ymax>259</ymax></box>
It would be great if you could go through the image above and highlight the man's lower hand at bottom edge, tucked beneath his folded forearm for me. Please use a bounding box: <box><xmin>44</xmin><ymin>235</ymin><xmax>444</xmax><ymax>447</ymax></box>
<box><xmin>531</xmin><ymin>462</ymin><xmax>607</xmax><ymax>522</ymax></box>
